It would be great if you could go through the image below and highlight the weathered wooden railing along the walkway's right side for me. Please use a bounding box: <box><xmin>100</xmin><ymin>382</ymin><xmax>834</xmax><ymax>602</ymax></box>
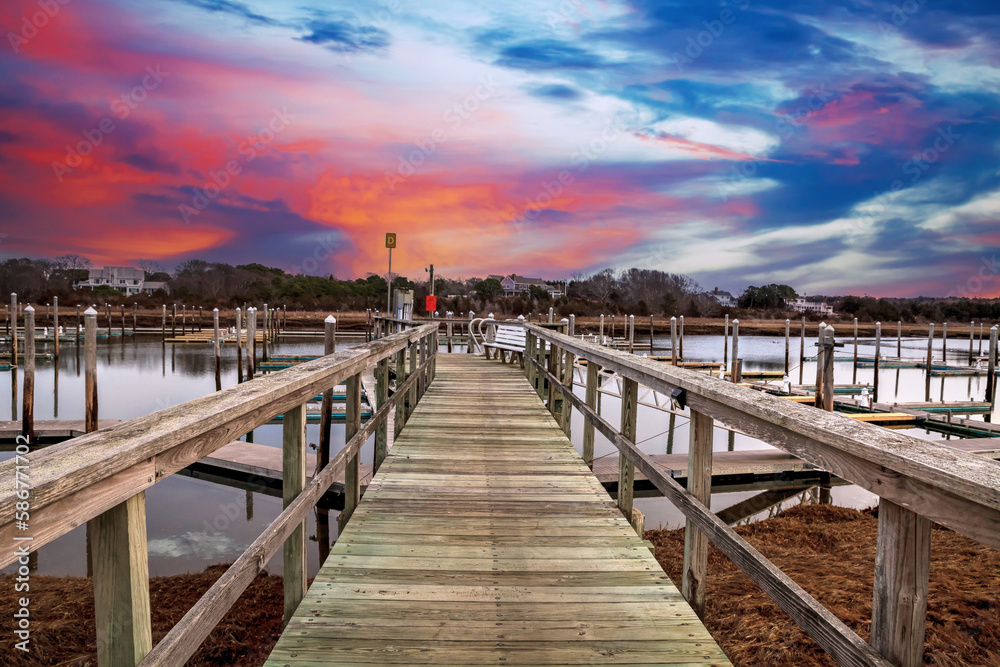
<box><xmin>526</xmin><ymin>324</ymin><xmax>1000</xmax><ymax>667</ymax></box>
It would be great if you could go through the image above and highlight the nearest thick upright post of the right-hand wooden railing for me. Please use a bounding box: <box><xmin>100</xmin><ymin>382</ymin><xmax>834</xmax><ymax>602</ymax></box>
<box><xmin>871</xmin><ymin>498</ymin><xmax>931</xmax><ymax>667</ymax></box>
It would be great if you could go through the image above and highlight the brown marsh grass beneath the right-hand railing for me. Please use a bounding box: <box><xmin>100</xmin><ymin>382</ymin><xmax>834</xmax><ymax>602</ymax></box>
<box><xmin>646</xmin><ymin>505</ymin><xmax>1000</xmax><ymax>667</ymax></box>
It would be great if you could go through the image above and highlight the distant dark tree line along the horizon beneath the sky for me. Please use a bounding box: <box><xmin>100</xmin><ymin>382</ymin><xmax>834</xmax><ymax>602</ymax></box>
<box><xmin>0</xmin><ymin>254</ymin><xmax>1000</xmax><ymax>322</ymax></box>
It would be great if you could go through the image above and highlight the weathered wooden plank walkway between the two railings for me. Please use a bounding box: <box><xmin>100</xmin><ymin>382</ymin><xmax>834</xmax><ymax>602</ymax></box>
<box><xmin>266</xmin><ymin>354</ymin><xmax>729</xmax><ymax>667</ymax></box>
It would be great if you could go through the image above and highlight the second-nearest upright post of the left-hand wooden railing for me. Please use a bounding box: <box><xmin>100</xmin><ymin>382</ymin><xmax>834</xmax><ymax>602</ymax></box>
<box><xmin>281</xmin><ymin>403</ymin><xmax>306</xmax><ymax>625</ymax></box>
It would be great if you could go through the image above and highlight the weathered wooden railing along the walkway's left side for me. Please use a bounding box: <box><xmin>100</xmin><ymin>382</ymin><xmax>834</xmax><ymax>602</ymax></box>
<box><xmin>0</xmin><ymin>323</ymin><xmax>438</xmax><ymax>667</ymax></box>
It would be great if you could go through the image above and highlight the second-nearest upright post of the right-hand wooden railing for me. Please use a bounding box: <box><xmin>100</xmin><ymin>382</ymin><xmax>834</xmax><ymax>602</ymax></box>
<box><xmin>681</xmin><ymin>410</ymin><xmax>714</xmax><ymax>618</ymax></box>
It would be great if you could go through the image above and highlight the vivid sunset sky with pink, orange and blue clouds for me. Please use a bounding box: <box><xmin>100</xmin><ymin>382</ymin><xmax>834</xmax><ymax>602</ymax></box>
<box><xmin>0</xmin><ymin>0</ymin><xmax>1000</xmax><ymax>297</ymax></box>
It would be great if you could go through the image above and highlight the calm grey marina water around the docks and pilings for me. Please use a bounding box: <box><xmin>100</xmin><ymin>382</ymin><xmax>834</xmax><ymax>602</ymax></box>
<box><xmin>0</xmin><ymin>336</ymin><xmax>996</xmax><ymax>576</ymax></box>
